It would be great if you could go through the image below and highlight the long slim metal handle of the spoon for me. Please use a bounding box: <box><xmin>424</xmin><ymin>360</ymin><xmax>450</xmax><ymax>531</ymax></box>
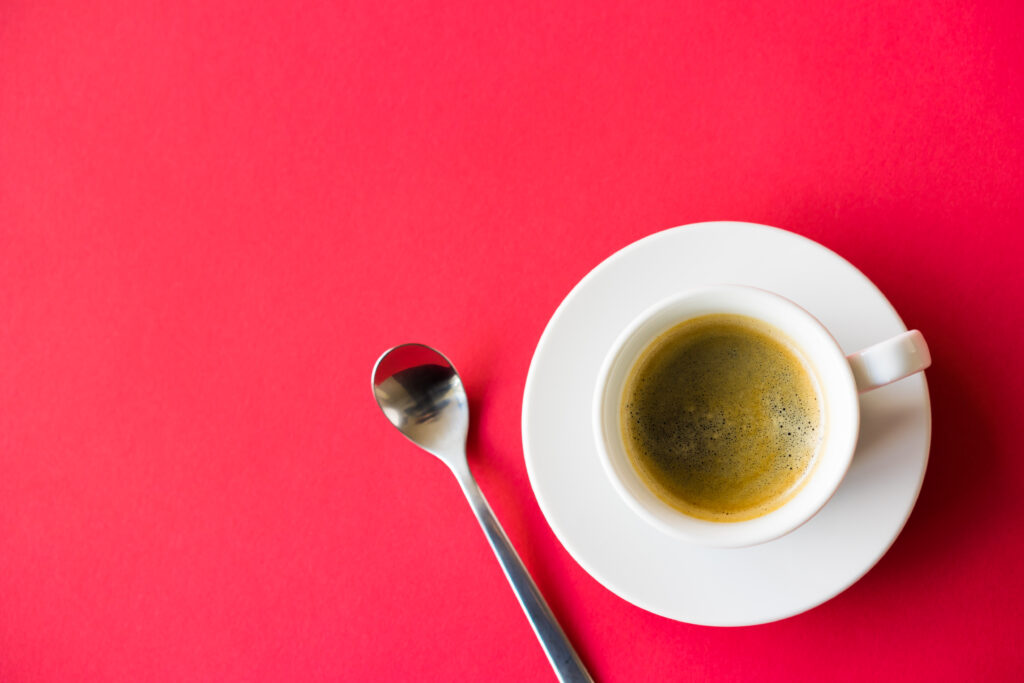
<box><xmin>456</xmin><ymin>471</ymin><xmax>594</xmax><ymax>683</ymax></box>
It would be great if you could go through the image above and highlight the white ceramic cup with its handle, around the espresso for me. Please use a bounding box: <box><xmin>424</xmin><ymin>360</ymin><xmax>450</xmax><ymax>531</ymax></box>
<box><xmin>594</xmin><ymin>285</ymin><xmax>931</xmax><ymax>548</ymax></box>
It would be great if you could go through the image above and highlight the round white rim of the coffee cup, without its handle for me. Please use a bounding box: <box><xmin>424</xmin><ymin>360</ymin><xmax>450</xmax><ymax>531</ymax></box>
<box><xmin>592</xmin><ymin>284</ymin><xmax>860</xmax><ymax>548</ymax></box>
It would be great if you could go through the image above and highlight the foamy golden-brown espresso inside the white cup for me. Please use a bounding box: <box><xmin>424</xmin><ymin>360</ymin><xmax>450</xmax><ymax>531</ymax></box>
<box><xmin>620</xmin><ymin>314</ymin><xmax>822</xmax><ymax>521</ymax></box>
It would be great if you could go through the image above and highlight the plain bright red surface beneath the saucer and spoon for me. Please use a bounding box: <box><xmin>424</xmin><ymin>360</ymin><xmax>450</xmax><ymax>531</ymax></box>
<box><xmin>0</xmin><ymin>0</ymin><xmax>1024</xmax><ymax>681</ymax></box>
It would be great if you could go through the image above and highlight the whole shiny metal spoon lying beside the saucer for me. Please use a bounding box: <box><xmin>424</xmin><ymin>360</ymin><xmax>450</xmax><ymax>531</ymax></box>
<box><xmin>373</xmin><ymin>344</ymin><xmax>593</xmax><ymax>683</ymax></box>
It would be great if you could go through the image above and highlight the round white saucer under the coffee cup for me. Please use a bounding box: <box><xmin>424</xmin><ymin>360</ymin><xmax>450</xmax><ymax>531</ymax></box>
<box><xmin>522</xmin><ymin>222</ymin><xmax>932</xmax><ymax>626</ymax></box>
